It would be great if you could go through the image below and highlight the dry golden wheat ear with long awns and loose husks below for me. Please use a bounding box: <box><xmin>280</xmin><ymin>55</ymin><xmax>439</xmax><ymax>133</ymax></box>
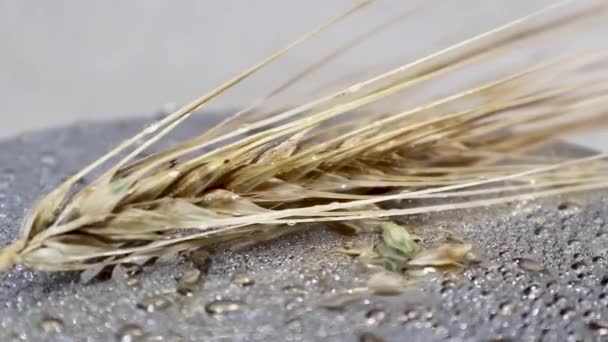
<box><xmin>0</xmin><ymin>1</ymin><xmax>608</xmax><ymax>271</ymax></box>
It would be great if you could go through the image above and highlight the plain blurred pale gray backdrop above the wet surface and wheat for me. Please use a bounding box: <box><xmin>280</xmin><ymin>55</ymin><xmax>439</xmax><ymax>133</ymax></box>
<box><xmin>0</xmin><ymin>0</ymin><xmax>600</xmax><ymax>149</ymax></box>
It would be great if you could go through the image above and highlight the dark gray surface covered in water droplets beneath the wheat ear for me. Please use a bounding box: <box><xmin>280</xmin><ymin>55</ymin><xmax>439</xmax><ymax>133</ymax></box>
<box><xmin>0</xmin><ymin>117</ymin><xmax>608</xmax><ymax>341</ymax></box>
